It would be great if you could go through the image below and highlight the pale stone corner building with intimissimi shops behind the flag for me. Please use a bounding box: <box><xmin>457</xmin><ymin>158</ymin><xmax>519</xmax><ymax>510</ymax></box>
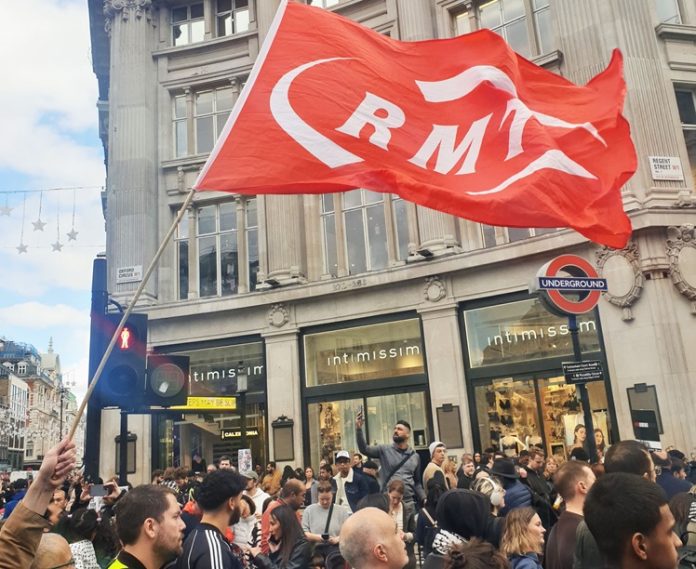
<box><xmin>89</xmin><ymin>0</ymin><xmax>696</xmax><ymax>480</ymax></box>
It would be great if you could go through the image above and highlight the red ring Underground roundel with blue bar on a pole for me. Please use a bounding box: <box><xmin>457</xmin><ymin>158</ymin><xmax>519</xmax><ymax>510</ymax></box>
<box><xmin>533</xmin><ymin>255</ymin><xmax>607</xmax><ymax>315</ymax></box>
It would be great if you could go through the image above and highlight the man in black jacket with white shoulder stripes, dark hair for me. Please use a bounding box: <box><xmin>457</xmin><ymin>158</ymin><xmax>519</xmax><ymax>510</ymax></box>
<box><xmin>174</xmin><ymin>469</ymin><xmax>251</xmax><ymax>569</ymax></box>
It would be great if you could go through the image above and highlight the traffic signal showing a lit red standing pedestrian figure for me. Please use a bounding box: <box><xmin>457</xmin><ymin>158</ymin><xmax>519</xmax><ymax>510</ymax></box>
<box><xmin>96</xmin><ymin>314</ymin><xmax>147</xmax><ymax>409</ymax></box>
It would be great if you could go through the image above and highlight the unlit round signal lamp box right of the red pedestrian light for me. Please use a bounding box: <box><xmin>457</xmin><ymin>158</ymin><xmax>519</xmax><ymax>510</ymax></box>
<box><xmin>145</xmin><ymin>354</ymin><xmax>189</xmax><ymax>407</ymax></box>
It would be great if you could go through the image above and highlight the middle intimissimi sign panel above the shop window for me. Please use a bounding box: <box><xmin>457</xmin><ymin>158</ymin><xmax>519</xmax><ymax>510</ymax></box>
<box><xmin>304</xmin><ymin>318</ymin><xmax>425</xmax><ymax>387</ymax></box>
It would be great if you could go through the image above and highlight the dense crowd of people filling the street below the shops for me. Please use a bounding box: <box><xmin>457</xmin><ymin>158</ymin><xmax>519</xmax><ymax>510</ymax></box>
<box><xmin>0</xmin><ymin>416</ymin><xmax>696</xmax><ymax>569</ymax></box>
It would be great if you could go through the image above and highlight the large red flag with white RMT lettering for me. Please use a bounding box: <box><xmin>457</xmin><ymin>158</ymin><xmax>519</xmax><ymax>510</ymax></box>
<box><xmin>195</xmin><ymin>2</ymin><xmax>636</xmax><ymax>248</ymax></box>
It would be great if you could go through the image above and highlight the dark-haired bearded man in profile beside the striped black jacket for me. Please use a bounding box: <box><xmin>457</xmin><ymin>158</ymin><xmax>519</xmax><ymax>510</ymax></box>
<box><xmin>109</xmin><ymin>484</ymin><xmax>186</xmax><ymax>569</ymax></box>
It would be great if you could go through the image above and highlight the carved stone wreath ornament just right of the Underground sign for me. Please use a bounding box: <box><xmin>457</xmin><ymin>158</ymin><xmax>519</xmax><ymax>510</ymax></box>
<box><xmin>595</xmin><ymin>241</ymin><xmax>644</xmax><ymax>321</ymax></box>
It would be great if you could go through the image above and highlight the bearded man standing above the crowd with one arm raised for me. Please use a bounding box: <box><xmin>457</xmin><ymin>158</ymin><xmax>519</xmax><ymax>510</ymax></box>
<box><xmin>355</xmin><ymin>412</ymin><xmax>425</xmax><ymax>505</ymax></box>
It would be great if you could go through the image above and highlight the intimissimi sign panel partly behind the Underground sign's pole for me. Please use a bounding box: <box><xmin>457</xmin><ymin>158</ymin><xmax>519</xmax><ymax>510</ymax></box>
<box><xmin>463</xmin><ymin>298</ymin><xmax>600</xmax><ymax>368</ymax></box>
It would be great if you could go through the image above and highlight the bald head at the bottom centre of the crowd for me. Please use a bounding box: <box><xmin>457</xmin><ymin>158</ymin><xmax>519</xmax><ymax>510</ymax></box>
<box><xmin>340</xmin><ymin>508</ymin><xmax>408</xmax><ymax>569</ymax></box>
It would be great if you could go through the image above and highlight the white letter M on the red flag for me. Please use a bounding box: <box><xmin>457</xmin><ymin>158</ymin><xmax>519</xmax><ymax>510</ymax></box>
<box><xmin>409</xmin><ymin>114</ymin><xmax>493</xmax><ymax>174</ymax></box>
